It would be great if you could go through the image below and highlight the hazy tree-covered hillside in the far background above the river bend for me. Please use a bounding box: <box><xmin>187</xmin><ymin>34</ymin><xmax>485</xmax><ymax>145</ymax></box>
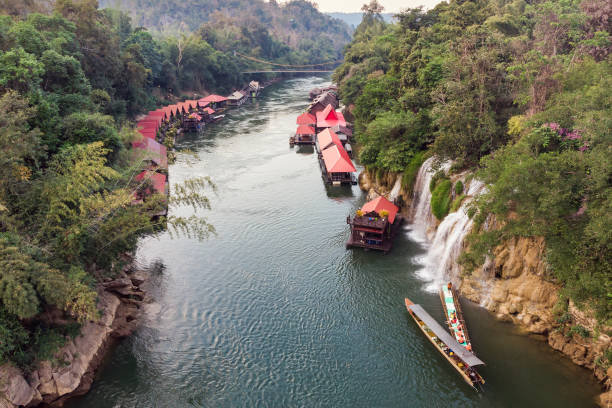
<box><xmin>100</xmin><ymin>0</ymin><xmax>351</xmax><ymax>65</ymax></box>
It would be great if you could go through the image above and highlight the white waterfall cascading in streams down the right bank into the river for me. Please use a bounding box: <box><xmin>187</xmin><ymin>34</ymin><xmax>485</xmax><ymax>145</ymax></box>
<box><xmin>410</xmin><ymin>159</ymin><xmax>485</xmax><ymax>292</ymax></box>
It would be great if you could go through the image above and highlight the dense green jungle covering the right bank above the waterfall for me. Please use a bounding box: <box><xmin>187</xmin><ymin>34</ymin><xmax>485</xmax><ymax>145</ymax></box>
<box><xmin>334</xmin><ymin>0</ymin><xmax>612</xmax><ymax>323</ymax></box>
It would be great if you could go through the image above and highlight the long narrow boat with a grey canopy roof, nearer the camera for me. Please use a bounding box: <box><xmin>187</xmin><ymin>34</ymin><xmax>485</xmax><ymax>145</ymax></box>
<box><xmin>405</xmin><ymin>298</ymin><xmax>485</xmax><ymax>390</ymax></box>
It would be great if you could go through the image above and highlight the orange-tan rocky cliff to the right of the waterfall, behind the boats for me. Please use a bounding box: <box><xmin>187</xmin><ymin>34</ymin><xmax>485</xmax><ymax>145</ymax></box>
<box><xmin>460</xmin><ymin>234</ymin><xmax>612</xmax><ymax>386</ymax></box>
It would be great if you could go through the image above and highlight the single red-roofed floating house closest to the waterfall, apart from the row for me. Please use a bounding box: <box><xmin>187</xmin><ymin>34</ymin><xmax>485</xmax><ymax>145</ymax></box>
<box><xmin>346</xmin><ymin>196</ymin><xmax>403</xmax><ymax>253</ymax></box>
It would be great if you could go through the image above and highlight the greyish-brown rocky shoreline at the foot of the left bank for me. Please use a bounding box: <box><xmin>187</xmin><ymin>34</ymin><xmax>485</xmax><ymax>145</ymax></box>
<box><xmin>0</xmin><ymin>266</ymin><xmax>148</xmax><ymax>408</ymax></box>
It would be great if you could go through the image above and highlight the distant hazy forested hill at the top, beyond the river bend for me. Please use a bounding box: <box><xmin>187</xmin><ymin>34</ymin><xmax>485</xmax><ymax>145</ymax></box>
<box><xmin>99</xmin><ymin>0</ymin><xmax>352</xmax><ymax>58</ymax></box>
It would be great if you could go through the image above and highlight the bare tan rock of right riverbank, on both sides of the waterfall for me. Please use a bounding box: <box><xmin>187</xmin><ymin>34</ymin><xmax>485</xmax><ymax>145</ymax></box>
<box><xmin>359</xmin><ymin>165</ymin><xmax>612</xmax><ymax>407</ymax></box>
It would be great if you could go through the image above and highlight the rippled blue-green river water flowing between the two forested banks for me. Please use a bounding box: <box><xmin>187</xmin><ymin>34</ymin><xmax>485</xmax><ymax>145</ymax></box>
<box><xmin>70</xmin><ymin>77</ymin><xmax>598</xmax><ymax>408</ymax></box>
